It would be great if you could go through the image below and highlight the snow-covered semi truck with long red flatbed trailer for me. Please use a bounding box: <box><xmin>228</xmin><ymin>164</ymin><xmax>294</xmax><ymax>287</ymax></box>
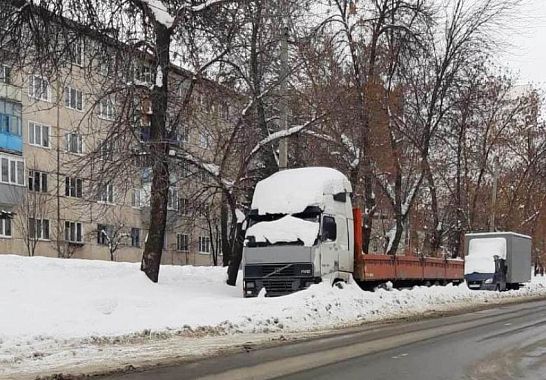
<box><xmin>243</xmin><ymin>167</ymin><xmax>464</xmax><ymax>297</ymax></box>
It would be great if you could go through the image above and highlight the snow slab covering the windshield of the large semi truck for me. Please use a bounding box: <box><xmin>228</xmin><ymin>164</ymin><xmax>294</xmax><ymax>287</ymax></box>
<box><xmin>246</xmin><ymin>215</ymin><xmax>319</xmax><ymax>247</ymax></box>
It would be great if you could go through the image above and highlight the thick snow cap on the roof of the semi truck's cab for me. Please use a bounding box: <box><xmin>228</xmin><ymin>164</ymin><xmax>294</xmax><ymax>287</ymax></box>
<box><xmin>252</xmin><ymin>167</ymin><xmax>352</xmax><ymax>215</ymax></box>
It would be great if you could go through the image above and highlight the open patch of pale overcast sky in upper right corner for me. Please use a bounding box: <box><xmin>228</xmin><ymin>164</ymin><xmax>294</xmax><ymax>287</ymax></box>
<box><xmin>499</xmin><ymin>0</ymin><xmax>546</xmax><ymax>90</ymax></box>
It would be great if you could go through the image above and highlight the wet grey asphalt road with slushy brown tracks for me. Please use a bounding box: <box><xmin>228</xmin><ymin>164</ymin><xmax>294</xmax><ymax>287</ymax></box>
<box><xmin>103</xmin><ymin>301</ymin><xmax>546</xmax><ymax>380</ymax></box>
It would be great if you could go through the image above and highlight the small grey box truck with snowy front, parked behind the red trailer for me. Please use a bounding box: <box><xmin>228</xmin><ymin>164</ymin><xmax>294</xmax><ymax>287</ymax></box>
<box><xmin>464</xmin><ymin>232</ymin><xmax>531</xmax><ymax>291</ymax></box>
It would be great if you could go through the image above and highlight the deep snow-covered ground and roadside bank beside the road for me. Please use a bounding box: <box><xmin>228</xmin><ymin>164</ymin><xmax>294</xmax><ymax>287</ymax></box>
<box><xmin>0</xmin><ymin>256</ymin><xmax>546</xmax><ymax>378</ymax></box>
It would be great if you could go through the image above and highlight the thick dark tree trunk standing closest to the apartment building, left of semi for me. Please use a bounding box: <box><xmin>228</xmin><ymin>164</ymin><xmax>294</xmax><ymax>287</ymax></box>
<box><xmin>141</xmin><ymin>22</ymin><xmax>171</xmax><ymax>282</ymax></box>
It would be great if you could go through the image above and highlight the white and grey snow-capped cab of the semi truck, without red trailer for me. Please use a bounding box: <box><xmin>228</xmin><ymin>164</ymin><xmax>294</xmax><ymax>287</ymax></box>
<box><xmin>243</xmin><ymin>167</ymin><xmax>354</xmax><ymax>297</ymax></box>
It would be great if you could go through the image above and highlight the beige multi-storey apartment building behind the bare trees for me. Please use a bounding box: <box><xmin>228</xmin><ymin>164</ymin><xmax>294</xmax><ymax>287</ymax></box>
<box><xmin>0</xmin><ymin>38</ymin><xmax>235</xmax><ymax>265</ymax></box>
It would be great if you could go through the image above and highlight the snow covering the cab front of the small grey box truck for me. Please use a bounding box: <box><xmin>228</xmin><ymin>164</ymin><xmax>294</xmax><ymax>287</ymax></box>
<box><xmin>464</xmin><ymin>237</ymin><xmax>506</xmax><ymax>274</ymax></box>
